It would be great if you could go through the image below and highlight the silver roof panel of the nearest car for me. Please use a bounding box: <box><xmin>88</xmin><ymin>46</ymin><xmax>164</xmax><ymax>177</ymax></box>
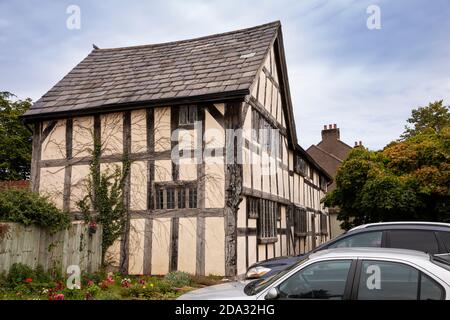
<box><xmin>309</xmin><ymin>248</ymin><xmax>430</xmax><ymax>261</ymax></box>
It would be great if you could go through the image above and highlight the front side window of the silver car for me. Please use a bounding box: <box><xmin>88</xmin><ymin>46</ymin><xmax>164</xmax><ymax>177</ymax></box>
<box><xmin>278</xmin><ymin>260</ymin><xmax>352</xmax><ymax>300</ymax></box>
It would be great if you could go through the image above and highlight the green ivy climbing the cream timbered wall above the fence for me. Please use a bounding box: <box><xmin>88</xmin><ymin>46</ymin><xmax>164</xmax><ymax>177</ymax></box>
<box><xmin>77</xmin><ymin>138</ymin><xmax>130</xmax><ymax>265</ymax></box>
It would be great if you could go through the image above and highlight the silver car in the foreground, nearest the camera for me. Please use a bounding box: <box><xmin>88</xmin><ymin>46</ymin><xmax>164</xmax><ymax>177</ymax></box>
<box><xmin>179</xmin><ymin>248</ymin><xmax>450</xmax><ymax>300</ymax></box>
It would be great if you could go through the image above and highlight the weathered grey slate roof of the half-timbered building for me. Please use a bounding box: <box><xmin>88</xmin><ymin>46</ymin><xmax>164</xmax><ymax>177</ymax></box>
<box><xmin>25</xmin><ymin>21</ymin><xmax>280</xmax><ymax>119</ymax></box>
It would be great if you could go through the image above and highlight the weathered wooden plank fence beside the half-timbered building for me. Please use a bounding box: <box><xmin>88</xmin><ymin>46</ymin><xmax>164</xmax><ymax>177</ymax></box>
<box><xmin>0</xmin><ymin>221</ymin><xmax>102</xmax><ymax>274</ymax></box>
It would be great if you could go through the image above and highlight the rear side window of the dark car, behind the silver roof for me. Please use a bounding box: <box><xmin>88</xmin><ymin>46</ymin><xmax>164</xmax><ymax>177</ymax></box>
<box><xmin>388</xmin><ymin>230</ymin><xmax>439</xmax><ymax>253</ymax></box>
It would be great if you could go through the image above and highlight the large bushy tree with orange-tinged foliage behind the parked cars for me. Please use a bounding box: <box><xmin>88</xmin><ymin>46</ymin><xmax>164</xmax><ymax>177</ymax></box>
<box><xmin>324</xmin><ymin>103</ymin><xmax>450</xmax><ymax>229</ymax></box>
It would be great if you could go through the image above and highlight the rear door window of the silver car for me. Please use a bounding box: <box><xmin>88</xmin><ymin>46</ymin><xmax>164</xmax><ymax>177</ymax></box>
<box><xmin>357</xmin><ymin>261</ymin><xmax>419</xmax><ymax>300</ymax></box>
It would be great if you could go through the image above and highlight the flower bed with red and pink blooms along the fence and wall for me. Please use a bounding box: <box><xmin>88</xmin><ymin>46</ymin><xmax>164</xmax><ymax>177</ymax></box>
<box><xmin>0</xmin><ymin>264</ymin><xmax>222</xmax><ymax>300</ymax></box>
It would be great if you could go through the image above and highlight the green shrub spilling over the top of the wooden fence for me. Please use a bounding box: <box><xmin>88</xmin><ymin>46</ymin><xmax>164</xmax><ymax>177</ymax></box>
<box><xmin>0</xmin><ymin>189</ymin><xmax>70</xmax><ymax>233</ymax></box>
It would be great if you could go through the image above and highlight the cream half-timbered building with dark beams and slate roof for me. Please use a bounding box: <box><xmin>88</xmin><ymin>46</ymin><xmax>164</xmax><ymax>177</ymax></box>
<box><xmin>24</xmin><ymin>22</ymin><xmax>330</xmax><ymax>276</ymax></box>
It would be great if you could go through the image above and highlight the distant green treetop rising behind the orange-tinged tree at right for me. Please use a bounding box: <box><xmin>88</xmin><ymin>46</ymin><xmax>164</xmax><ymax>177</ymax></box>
<box><xmin>401</xmin><ymin>100</ymin><xmax>450</xmax><ymax>139</ymax></box>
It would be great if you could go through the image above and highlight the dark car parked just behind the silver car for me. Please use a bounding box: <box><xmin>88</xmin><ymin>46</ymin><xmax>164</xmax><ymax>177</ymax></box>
<box><xmin>246</xmin><ymin>222</ymin><xmax>450</xmax><ymax>279</ymax></box>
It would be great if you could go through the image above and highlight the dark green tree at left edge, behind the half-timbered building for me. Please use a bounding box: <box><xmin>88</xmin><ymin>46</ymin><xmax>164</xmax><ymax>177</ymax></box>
<box><xmin>0</xmin><ymin>92</ymin><xmax>31</xmax><ymax>180</ymax></box>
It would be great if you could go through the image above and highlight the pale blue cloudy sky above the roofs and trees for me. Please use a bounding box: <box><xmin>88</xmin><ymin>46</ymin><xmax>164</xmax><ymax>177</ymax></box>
<box><xmin>0</xmin><ymin>0</ymin><xmax>450</xmax><ymax>150</ymax></box>
